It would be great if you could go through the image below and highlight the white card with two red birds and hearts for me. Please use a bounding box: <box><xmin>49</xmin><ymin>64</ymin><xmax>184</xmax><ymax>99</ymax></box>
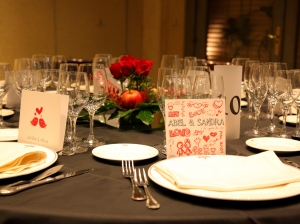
<box><xmin>18</xmin><ymin>90</ymin><xmax>69</xmax><ymax>151</ymax></box>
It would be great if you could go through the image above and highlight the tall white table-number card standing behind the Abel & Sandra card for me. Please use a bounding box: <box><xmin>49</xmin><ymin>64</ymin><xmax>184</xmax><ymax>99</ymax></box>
<box><xmin>214</xmin><ymin>65</ymin><xmax>243</xmax><ymax>139</ymax></box>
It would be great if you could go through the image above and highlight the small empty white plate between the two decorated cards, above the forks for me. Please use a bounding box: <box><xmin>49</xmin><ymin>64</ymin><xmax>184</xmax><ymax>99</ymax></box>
<box><xmin>92</xmin><ymin>143</ymin><xmax>158</xmax><ymax>161</ymax></box>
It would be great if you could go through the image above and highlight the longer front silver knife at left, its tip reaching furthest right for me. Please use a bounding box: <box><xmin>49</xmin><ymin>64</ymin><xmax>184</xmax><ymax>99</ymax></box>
<box><xmin>0</xmin><ymin>169</ymin><xmax>95</xmax><ymax>195</ymax></box>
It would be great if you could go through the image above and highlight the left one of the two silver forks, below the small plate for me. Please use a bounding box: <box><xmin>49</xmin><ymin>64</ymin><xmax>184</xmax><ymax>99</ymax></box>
<box><xmin>122</xmin><ymin>160</ymin><xmax>147</xmax><ymax>201</ymax></box>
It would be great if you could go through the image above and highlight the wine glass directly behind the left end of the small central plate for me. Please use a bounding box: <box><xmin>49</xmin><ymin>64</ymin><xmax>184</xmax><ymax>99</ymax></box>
<box><xmin>79</xmin><ymin>62</ymin><xmax>108</xmax><ymax>147</ymax></box>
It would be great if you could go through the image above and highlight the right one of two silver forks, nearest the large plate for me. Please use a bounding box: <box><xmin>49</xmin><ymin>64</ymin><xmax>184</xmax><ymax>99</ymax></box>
<box><xmin>134</xmin><ymin>168</ymin><xmax>160</xmax><ymax>209</ymax></box>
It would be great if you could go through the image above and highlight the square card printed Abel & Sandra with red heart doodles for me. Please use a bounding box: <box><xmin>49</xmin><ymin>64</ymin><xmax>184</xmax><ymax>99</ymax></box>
<box><xmin>165</xmin><ymin>99</ymin><xmax>226</xmax><ymax>158</ymax></box>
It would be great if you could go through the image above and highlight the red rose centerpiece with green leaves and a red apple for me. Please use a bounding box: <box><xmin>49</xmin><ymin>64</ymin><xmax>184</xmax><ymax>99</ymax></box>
<box><xmin>98</xmin><ymin>56</ymin><xmax>160</xmax><ymax>129</ymax></box>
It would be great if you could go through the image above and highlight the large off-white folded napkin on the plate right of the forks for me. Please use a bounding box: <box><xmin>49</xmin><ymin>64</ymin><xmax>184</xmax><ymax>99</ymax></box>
<box><xmin>154</xmin><ymin>151</ymin><xmax>300</xmax><ymax>191</ymax></box>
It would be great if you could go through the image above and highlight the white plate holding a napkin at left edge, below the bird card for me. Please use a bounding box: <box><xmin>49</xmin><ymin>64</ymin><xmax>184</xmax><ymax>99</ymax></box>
<box><xmin>0</xmin><ymin>142</ymin><xmax>58</xmax><ymax>179</ymax></box>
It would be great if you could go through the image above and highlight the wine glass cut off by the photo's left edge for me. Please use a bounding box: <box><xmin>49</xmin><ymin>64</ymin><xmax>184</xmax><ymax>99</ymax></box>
<box><xmin>0</xmin><ymin>62</ymin><xmax>14</xmax><ymax>128</ymax></box>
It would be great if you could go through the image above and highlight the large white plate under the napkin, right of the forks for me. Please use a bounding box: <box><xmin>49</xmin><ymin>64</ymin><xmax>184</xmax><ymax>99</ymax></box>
<box><xmin>148</xmin><ymin>155</ymin><xmax>300</xmax><ymax>201</ymax></box>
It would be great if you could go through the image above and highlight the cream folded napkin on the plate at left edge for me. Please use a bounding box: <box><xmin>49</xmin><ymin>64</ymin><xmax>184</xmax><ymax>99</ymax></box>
<box><xmin>0</xmin><ymin>148</ymin><xmax>47</xmax><ymax>174</ymax></box>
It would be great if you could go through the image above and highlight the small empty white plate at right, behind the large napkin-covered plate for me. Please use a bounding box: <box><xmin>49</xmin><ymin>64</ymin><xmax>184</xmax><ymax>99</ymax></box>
<box><xmin>246</xmin><ymin>137</ymin><xmax>300</xmax><ymax>152</ymax></box>
